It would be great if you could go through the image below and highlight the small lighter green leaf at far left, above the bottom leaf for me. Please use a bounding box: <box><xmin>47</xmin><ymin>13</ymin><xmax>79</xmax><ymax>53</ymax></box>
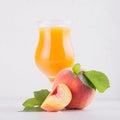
<box><xmin>23</xmin><ymin>98</ymin><xmax>40</xmax><ymax>107</ymax></box>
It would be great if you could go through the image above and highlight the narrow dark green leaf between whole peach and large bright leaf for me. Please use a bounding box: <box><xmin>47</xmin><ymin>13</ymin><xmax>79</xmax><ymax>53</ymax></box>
<box><xmin>78</xmin><ymin>74</ymin><xmax>96</xmax><ymax>90</ymax></box>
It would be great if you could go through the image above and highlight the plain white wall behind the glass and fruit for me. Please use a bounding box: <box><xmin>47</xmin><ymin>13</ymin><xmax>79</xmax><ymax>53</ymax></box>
<box><xmin>0</xmin><ymin>0</ymin><xmax>120</xmax><ymax>100</ymax></box>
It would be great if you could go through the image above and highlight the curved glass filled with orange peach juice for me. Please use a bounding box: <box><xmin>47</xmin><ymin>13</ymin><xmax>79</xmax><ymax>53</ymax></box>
<box><xmin>35</xmin><ymin>21</ymin><xmax>74</xmax><ymax>82</ymax></box>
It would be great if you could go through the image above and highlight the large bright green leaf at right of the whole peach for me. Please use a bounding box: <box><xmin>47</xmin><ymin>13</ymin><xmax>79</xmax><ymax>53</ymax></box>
<box><xmin>83</xmin><ymin>70</ymin><xmax>110</xmax><ymax>93</ymax></box>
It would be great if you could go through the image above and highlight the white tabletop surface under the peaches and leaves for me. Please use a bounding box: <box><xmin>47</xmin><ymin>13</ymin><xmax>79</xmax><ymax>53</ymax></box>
<box><xmin>0</xmin><ymin>98</ymin><xmax>120</xmax><ymax>120</ymax></box>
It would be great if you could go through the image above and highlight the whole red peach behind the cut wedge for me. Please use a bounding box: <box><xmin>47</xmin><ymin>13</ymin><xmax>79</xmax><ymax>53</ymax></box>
<box><xmin>53</xmin><ymin>69</ymin><xmax>95</xmax><ymax>109</ymax></box>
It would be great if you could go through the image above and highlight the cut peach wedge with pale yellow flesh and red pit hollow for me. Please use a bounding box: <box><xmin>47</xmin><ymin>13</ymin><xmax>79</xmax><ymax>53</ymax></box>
<box><xmin>41</xmin><ymin>84</ymin><xmax>72</xmax><ymax>112</ymax></box>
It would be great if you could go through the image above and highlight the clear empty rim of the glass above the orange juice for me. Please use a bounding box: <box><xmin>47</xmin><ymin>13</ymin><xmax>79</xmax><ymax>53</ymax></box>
<box><xmin>37</xmin><ymin>20</ymin><xmax>72</xmax><ymax>28</ymax></box>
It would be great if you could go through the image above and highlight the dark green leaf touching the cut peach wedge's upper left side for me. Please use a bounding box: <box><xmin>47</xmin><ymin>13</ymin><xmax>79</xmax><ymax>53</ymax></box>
<box><xmin>34</xmin><ymin>89</ymin><xmax>50</xmax><ymax>106</ymax></box>
